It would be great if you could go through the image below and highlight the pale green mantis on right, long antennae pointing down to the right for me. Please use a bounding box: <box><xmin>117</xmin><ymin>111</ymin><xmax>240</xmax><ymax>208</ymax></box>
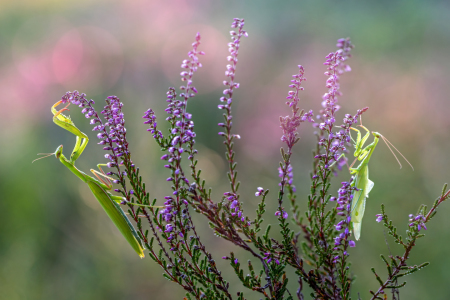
<box><xmin>349</xmin><ymin>120</ymin><xmax>414</xmax><ymax>240</ymax></box>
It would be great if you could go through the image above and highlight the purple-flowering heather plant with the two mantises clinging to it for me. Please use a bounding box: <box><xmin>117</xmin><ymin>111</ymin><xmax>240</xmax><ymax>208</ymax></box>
<box><xmin>44</xmin><ymin>18</ymin><xmax>450</xmax><ymax>299</ymax></box>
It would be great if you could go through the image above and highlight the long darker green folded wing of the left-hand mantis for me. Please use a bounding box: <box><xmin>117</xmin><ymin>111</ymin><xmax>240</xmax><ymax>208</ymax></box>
<box><xmin>87</xmin><ymin>181</ymin><xmax>144</xmax><ymax>258</ymax></box>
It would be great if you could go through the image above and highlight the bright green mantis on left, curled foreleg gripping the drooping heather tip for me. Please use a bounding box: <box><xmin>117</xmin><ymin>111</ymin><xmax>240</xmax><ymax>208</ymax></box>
<box><xmin>33</xmin><ymin>101</ymin><xmax>156</xmax><ymax>258</ymax></box>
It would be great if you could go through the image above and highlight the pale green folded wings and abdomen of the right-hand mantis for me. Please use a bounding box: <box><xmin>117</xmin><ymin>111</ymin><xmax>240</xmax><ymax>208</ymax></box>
<box><xmin>351</xmin><ymin>164</ymin><xmax>374</xmax><ymax>240</ymax></box>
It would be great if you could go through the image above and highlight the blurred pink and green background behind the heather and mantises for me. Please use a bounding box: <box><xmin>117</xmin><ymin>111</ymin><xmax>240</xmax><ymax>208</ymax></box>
<box><xmin>0</xmin><ymin>0</ymin><xmax>450</xmax><ymax>300</ymax></box>
